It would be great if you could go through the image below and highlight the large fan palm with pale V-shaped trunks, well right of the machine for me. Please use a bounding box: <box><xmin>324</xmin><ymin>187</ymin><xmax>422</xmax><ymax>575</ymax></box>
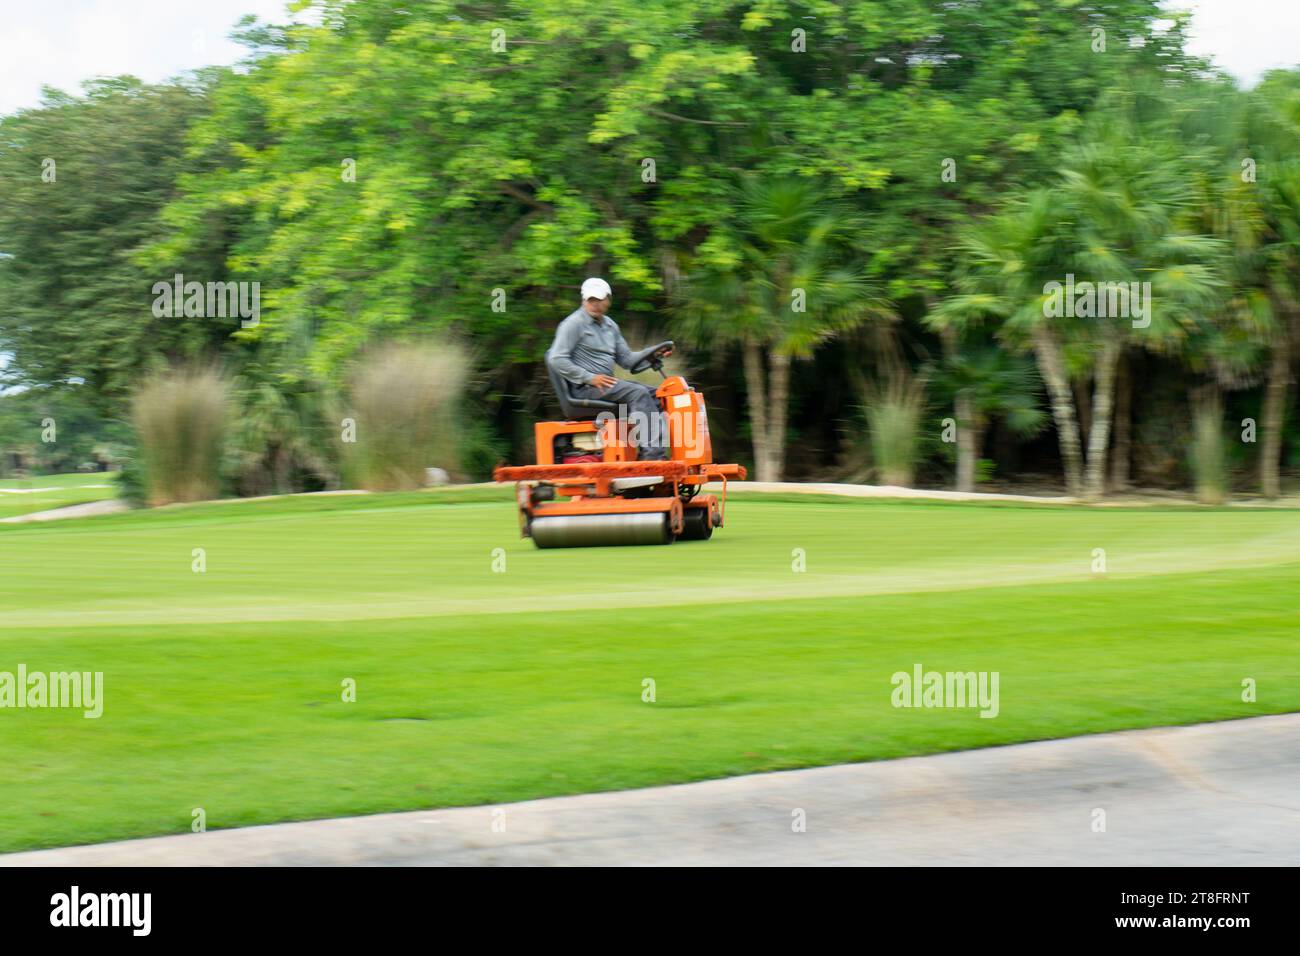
<box><xmin>931</xmin><ymin>95</ymin><xmax>1222</xmax><ymax>498</ymax></box>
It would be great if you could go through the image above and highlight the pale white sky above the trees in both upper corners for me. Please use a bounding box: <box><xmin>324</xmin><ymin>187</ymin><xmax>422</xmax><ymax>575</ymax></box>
<box><xmin>0</xmin><ymin>0</ymin><xmax>1300</xmax><ymax>114</ymax></box>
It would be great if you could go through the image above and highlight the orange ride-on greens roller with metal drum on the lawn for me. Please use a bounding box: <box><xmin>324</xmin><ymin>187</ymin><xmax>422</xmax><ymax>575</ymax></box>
<box><xmin>493</xmin><ymin>342</ymin><xmax>745</xmax><ymax>548</ymax></box>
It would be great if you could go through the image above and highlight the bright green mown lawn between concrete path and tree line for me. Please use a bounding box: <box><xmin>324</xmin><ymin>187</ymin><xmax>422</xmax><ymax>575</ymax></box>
<box><xmin>0</xmin><ymin>490</ymin><xmax>1300</xmax><ymax>849</ymax></box>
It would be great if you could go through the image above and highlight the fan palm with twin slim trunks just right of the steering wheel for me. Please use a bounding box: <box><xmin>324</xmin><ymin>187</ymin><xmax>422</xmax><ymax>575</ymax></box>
<box><xmin>673</xmin><ymin>177</ymin><xmax>888</xmax><ymax>481</ymax></box>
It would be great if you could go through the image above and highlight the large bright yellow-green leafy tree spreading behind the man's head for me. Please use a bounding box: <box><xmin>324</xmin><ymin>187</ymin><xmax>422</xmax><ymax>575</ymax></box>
<box><xmin>144</xmin><ymin>0</ymin><xmax>1186</xmax><ymax>468</ymax></box>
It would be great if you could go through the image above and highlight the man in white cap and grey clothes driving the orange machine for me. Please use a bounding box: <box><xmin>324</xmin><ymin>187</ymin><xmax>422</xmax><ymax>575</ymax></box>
<box><xmin>550</xmin><ymin>278</ymin><xmax>671</xmax><ymax>462</ymax></box>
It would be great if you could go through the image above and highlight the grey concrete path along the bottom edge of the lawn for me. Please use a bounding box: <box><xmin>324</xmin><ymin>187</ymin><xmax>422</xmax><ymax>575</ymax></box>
<box><xmin>0</xmin><ymin>714</ymin><xmax>1300</xmax><ymax>866</ymax></box>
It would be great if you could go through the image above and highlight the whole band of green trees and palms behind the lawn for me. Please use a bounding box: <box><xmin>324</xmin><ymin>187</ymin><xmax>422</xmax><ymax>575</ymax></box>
<box><xmin>0</xmin><ymin>0</ymin><xmax>1300</xmax><ymax>494</ymax></box>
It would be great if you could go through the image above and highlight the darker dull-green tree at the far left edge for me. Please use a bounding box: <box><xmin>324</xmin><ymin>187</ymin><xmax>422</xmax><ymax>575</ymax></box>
<box><xmin>0</xmin><ymin>77</ymin><xmax>228</xmax><ymax>414</ymax></box>
